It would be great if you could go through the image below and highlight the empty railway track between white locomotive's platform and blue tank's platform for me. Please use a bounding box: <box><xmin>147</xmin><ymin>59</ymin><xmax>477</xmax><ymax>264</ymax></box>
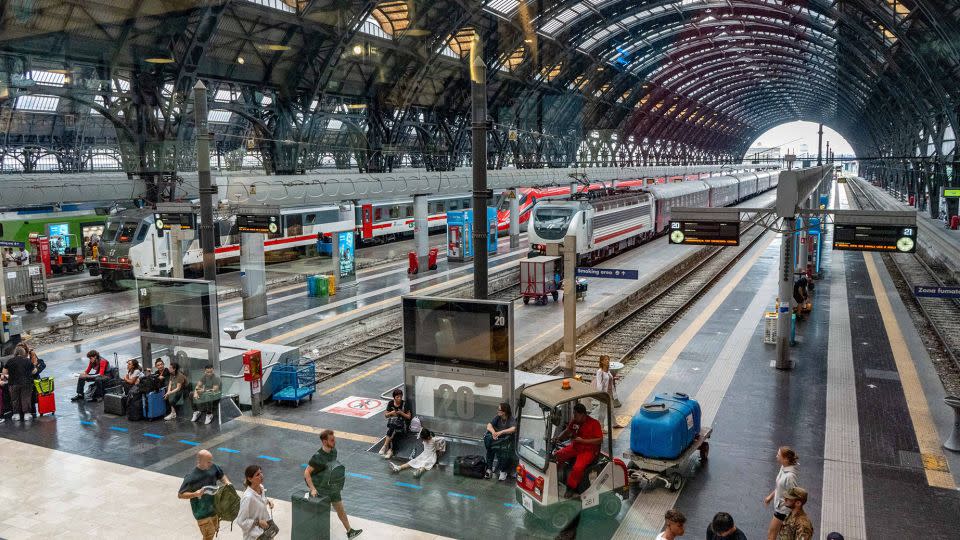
<box><xmin>538</xmin><ymin>209</ymin><xmax>765</xmax><ymax>380</ymax></box>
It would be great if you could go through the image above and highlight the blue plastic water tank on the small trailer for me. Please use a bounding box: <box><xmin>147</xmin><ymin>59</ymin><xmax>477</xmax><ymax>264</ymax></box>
<box><xmin>630</xmin><ymin>394</ymin><xmax>700</xmax><ymax>459</ymax></box>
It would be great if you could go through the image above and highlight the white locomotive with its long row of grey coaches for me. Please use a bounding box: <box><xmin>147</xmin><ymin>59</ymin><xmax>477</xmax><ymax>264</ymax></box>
<box><xmin>527</xmin><ymin>172</ymin><xmax>779</xmax><ymax>265</ymax></box>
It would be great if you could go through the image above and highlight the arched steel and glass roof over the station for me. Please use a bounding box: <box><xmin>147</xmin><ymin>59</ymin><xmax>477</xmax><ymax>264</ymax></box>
<box><xmin>0</xmin><ymin>0</ymin><xmax>960</xmax><ymax>180</ymax></box>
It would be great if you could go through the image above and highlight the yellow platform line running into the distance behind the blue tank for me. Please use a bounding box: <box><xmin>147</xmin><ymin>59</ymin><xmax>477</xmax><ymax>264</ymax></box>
<box><xmin>615</xmin><ymin>235</ymin><xmax>773</xmax><ymax>438</ymax></box>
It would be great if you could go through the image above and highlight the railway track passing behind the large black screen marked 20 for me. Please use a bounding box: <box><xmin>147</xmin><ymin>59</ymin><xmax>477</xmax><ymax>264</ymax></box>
<box><xmin>304</xmin><ymin>283</ymin><xmax>520</xmax><ymax>383</ymax></box>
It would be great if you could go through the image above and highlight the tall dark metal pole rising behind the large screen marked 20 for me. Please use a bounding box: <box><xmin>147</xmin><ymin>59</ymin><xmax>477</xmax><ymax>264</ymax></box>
<box><xmin>470</xmin><ymin>38</ymin><xmax>490</xmax><ymax>300</ymax></box>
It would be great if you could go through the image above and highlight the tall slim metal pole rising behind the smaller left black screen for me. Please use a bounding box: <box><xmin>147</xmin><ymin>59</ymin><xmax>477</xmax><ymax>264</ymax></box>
<box><xmin>193</xmin><ymin>80</ymin><xmax>217</xmax><ymax>281</ymax></box>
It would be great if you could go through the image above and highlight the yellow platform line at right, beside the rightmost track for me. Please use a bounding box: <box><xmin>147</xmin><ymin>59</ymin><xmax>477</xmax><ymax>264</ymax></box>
<box><xmin>863</xmin><ymin>253</ymin><xmax>957</xmax><ymax>489</ymax></box>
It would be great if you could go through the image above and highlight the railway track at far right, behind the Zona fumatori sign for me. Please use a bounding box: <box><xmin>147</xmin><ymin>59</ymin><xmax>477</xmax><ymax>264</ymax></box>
<box><xmin>847</xmin><ymin>180</ymin><xmax>960</xmax><ymax>376</ymax></box>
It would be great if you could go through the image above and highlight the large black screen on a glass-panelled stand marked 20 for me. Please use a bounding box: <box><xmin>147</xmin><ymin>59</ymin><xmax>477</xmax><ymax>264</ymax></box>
<box><xmin>403</xmin><ymin>296</ymin><xmax>514</xmax><ymax>438</ymax></box>
